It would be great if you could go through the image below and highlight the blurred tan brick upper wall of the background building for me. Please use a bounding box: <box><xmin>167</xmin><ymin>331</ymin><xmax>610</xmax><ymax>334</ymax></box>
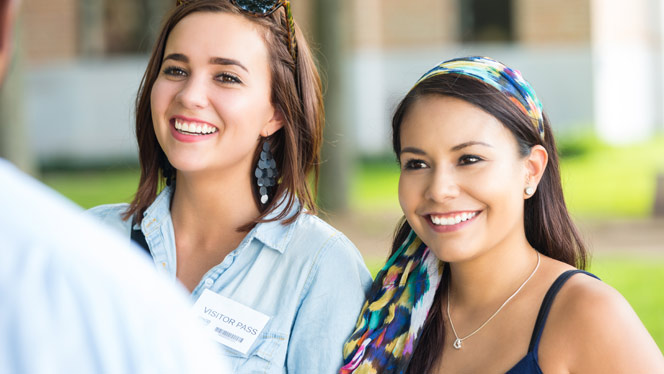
<box><xmin>23</xmin><ymin>0</ymin><xmax>590</xmax><ymax>63</ymax></box>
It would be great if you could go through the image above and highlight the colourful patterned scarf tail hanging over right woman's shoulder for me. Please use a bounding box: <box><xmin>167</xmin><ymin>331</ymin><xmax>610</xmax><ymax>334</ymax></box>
<box><xmin>340</xmin><ymin>230</ymin><xmax>443</xmax><ymax>374</ymax></box>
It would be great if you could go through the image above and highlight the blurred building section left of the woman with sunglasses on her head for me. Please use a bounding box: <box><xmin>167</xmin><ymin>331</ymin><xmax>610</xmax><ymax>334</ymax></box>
<box><xmin>9</xmin><ymin>0</ymin><xmax>171</xmax><ymax>168</ymax></box>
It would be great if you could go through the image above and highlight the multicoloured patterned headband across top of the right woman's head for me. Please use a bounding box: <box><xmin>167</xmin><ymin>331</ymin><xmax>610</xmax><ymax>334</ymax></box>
<box><xmin>411</xmin><ymin>56</ymin><xmax>544</xmax><ymax>139</ymax></box>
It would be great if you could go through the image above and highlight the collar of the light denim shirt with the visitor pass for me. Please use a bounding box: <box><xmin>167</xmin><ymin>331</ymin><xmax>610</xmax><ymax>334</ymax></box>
<box><xmin>141</xmin><ymin>186</ymin><xmax>304</xmax><ymax>253</ymax></box>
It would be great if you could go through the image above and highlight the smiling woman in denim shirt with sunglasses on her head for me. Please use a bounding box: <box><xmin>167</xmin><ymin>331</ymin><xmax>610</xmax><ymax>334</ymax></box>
<box><xmin>92</xmin><ymin>0</ymin><xmax>371</xmax><ymax>373</ymax></box>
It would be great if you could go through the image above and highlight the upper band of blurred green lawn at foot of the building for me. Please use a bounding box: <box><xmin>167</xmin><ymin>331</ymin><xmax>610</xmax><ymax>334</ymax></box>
<box><xmin>42</xmin><ymin>136</ymin><xmax>664</xmax><ymax>218</ymax></box>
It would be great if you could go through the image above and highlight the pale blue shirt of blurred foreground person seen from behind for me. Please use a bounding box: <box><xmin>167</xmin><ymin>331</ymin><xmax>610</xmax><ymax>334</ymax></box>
<box><xmin>0</xmin><ymin>159</ymin><xmax>229</xmax><ymax>374</ymax></box>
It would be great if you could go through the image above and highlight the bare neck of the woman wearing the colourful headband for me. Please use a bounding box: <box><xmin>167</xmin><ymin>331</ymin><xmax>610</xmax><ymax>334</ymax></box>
<box><xmin>450</xmin><ymin>234</ymin><xmax>537</xmax><ymax>310</ymax></box>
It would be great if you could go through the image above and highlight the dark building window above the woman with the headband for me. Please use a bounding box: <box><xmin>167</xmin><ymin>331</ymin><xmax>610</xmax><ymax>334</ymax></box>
<box><xmin>458</xmin><ymin>0</ymin><xmax>514</xmax><ymax>43</ymax></box>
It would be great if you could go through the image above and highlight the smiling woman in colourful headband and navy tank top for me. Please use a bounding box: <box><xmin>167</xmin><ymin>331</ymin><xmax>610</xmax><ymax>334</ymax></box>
<box><xmin>341</xmin><ymin>57</ymin><xmax>664</xmax><ymax>374</ymax></box>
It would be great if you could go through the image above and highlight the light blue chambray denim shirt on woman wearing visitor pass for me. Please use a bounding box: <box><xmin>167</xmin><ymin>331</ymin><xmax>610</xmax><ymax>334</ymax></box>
<box><xmin>89</xmin><ymin>187</ymin><xmax>372</xmax><ymax>374</ymax></box>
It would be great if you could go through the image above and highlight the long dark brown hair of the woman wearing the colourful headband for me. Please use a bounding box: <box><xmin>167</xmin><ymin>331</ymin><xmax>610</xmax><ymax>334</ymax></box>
<box><xmin>392</xmin><ymin>74</ymin><xmax>587</xmax><ymax>374</ymax></box>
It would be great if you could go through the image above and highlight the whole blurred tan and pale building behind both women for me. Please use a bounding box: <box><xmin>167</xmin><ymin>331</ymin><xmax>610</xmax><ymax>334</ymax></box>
<box><xmin>0</xmin><ymin>0</ymin><xmax>664</xmax><ymax>169</ymax></box>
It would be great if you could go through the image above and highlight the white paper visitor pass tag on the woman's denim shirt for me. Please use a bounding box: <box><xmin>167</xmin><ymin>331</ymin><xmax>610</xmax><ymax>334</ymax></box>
<box><xmin>194</xmin><ymin>289</ymin><xmax>270</xmax><ymax>354</ymax></box>
